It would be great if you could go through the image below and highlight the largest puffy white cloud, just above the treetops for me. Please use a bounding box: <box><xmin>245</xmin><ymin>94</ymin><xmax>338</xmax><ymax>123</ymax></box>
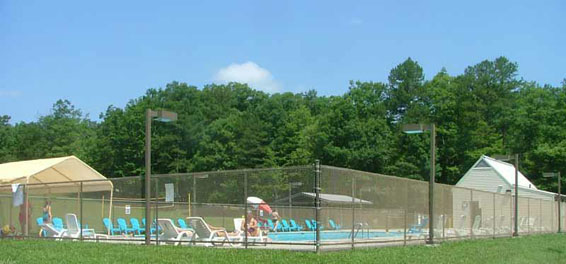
<box><xmin>214</xmin><ymin>61</ymin><xmax>281</xmax><ymax>93</ymax></box>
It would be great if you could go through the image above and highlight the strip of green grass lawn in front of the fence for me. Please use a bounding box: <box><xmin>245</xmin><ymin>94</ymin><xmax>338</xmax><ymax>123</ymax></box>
<box><xmin>0</xmin><ymin>234</ymin><xmax>566</xmax><ymax>264</ymax></box>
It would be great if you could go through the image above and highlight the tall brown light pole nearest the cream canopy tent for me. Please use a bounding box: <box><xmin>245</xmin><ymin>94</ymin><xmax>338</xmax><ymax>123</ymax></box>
<box><xmin>145</xmin><ymin>108</ymin><xmax>177</xmax><ymax>245</ymax></box>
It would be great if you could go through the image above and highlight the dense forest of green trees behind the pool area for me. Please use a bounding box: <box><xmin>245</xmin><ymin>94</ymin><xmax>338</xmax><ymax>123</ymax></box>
<box><xmin>0</xmin><ymin>57</ymin><xmax>566</xmax><ymax>190</ymax></box>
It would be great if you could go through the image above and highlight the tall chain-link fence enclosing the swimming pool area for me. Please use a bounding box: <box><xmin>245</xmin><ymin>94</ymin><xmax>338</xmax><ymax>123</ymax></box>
<box><xmin>0</xmin><ymin>163</ymin><xmax>566</xmax><ymax>251</ymax></box>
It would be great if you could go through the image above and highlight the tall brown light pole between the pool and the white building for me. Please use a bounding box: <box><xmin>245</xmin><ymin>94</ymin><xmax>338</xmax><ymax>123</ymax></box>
<box><xmin>402</xmin><ymin>123</ymin><xmax>436</xmax><ymax>244</ymax></box>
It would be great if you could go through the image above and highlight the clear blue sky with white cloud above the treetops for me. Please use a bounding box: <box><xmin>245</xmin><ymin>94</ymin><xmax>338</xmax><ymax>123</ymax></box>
<box><xmin>0</xmin><ymin>0</ymin><xmax>566</xmax><ymax>122</ymax></box>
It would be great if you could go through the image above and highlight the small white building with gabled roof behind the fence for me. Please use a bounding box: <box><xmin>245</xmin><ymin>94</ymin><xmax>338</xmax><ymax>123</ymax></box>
<box><xmin>452</xmin><ymin>156</ymin><xmax>558</xmax><ymax>234</ymax></box>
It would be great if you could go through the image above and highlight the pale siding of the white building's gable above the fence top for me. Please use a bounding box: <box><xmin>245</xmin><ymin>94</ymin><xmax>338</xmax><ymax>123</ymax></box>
<box><xmin>456</xmin><ymin>168</ymin><xmax>511</xmax><ymax>193</ymax></box>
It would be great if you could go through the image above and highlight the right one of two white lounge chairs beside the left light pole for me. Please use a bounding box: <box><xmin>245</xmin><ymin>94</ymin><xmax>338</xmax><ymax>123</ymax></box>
<box><xmin>187</xmin><ymin>217</ymin><xmax>241</xmax><ymax>246</ymax></box>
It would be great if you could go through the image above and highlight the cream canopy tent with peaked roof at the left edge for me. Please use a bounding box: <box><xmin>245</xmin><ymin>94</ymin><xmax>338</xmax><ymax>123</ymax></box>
<box><xmin>0</xmin><ymin>156</ymin><xmax>114</xmax><ymax>219</ymax></box>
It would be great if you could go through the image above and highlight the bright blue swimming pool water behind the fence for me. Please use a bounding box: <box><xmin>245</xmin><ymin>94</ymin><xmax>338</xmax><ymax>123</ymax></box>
<box><xmin>268</xmin><ymin>230</ymin><xmax>403</xmax><ymax>241</ymax></box>
